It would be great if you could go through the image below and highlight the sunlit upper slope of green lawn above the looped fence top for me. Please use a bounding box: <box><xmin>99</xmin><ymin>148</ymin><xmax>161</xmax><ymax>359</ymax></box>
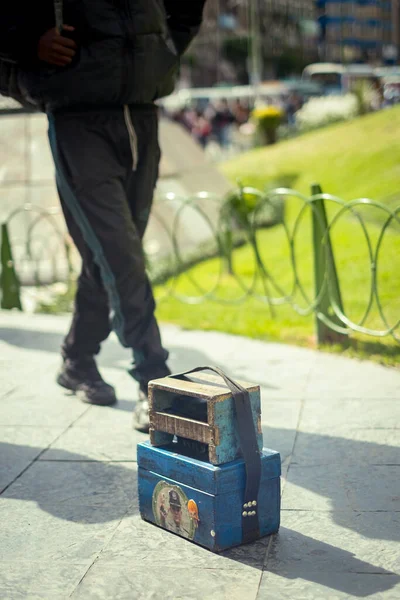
<box><xmin>222</xmin><ymin>107</ymin><xmax>400</xmax><ymax>211</ymax></box>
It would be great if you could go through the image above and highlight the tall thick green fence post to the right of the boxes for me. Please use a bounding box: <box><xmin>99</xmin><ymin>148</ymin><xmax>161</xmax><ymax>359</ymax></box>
<box><xmin>311</xmin><ymin>184</ymin><xmax>349</xmax><ymax>345</ymax></box>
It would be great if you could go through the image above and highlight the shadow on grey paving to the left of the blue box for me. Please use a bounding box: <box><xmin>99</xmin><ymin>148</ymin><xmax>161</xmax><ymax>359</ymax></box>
<box><xmin>0</xmin><ymin>443</ymin><xmax>138</xmax><ymax>524</ymax></box>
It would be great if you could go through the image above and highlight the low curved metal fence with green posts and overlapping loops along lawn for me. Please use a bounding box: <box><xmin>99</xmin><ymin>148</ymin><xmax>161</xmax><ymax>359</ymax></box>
<box><xmin>0</xmin><ymin>186</ymin><xmax>400</xmax><ymax>342</ymax></box>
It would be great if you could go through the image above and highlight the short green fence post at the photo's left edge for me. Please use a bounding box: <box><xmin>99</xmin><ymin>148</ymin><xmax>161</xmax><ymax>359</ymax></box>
<box><xmin>0</xmin><ymin>223</ymin><xmax>22</xmax><ymax>310</ymax></box>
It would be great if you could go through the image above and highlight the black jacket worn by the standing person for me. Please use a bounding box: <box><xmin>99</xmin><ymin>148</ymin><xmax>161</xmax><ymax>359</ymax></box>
<box><xmin>0</xmin><ymin>0</ymin><xmax>206</xmax><ymax>111</ymax></box>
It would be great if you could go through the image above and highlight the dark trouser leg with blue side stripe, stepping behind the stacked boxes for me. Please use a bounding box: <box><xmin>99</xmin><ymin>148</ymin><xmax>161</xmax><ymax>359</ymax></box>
<box><xmin>49</xmin><ymin>108</ymin><xmax>167</xmax><ymax>408</ymax></box>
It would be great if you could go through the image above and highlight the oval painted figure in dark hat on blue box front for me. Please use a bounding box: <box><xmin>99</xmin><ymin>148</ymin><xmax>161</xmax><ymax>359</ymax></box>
<box><xmin>153</xmin><ymin>481</ymin><xmax>196</xmax><ymax>540</ymax></box>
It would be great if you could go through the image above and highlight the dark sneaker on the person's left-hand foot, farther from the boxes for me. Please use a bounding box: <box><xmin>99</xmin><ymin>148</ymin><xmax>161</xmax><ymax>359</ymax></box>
<box><xmin>57</xmin><ymin>356</ymin><xmax>117</xmax><ymax>406</ymax></box>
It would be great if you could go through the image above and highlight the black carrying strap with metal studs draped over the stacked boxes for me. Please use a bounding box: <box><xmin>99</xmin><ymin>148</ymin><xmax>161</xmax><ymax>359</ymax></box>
<box><xmin>171</xmin><ymin>367</ymin><xmax>261</xmax><ymax>542</ymax></box>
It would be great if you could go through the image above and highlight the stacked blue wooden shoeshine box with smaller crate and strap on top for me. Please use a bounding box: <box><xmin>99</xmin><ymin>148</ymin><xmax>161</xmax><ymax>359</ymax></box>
<box><xmin>137</xmin><ymin>367</ymin><xmax>281</xmax><ymax>552</ymax></box>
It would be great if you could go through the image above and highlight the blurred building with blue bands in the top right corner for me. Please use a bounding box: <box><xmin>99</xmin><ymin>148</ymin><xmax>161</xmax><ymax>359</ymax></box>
<box><xmin>316</xmin><ymin>0</ymin><xmax>400</xmax><ymax>64</ymax></box>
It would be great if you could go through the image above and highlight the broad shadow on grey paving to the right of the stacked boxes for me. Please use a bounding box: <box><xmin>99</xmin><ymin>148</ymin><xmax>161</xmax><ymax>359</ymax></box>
<box><xmin>263</xmin><ymin>423</ymin><xmax>400</xmax><ymax>542</ymax></box>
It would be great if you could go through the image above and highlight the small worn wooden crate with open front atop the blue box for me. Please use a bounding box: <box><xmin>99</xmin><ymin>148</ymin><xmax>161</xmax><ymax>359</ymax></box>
<box><xmin>149</xmin><ymin>372</ymin><xmax>263</xmax><ymax>465</ymax></box>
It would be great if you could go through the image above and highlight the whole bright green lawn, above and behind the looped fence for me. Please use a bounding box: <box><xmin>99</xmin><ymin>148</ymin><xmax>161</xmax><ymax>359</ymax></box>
<box><xmin>156</xmin><ymin>107</ymin><xmax>400</xmax><ymax>365</ymax></box>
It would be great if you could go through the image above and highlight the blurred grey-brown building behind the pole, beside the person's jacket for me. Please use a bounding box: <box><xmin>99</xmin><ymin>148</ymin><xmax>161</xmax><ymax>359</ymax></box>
<box><xmin>182</xmin><ymin>0</ymin><xmax>318</xmax><ymax>87</ymax></box>
